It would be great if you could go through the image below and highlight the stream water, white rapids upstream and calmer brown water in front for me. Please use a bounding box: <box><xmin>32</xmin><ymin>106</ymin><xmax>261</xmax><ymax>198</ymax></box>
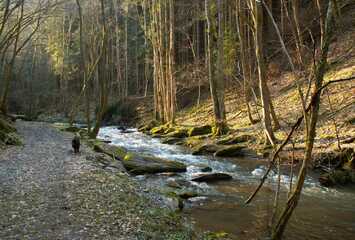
<box><xmin>99</xmin><ymin>127</ymin><xmax>355</xmax><ymax>240</ymax></box>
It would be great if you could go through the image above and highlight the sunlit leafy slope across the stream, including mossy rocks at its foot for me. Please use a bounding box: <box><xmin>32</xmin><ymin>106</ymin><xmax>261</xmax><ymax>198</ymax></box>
<box><xmin>134</xmin><ymin>23</ymin><xmax>355</xmax><ymax>185</ymax></box>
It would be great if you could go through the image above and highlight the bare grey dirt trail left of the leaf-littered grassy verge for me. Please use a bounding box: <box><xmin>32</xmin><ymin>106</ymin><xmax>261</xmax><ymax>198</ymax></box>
<box><xmin>0</xmin><ymin>122</ymin><xmax>96</xmax><ymax>239</ymax></box>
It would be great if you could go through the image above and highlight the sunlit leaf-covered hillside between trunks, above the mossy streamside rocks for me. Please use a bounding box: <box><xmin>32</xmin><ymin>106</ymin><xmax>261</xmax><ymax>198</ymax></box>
<box><xmin>138</xmin><ymin>26</ymin><xmax>355</xmax><ymax>154</ymax></box>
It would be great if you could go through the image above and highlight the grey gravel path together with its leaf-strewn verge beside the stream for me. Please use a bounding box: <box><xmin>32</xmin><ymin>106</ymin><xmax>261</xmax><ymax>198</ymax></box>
<box><xmin>0</xmin><ymin>122</ymin><xmax>192</xmax><ymax>240</ymax></box>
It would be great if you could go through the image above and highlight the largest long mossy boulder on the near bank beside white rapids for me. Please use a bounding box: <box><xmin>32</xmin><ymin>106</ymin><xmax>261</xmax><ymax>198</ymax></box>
<box><xmin>122</xmin><ymin>153</ymin><xmax>186</xmax><ymax>175</ymax></box>
